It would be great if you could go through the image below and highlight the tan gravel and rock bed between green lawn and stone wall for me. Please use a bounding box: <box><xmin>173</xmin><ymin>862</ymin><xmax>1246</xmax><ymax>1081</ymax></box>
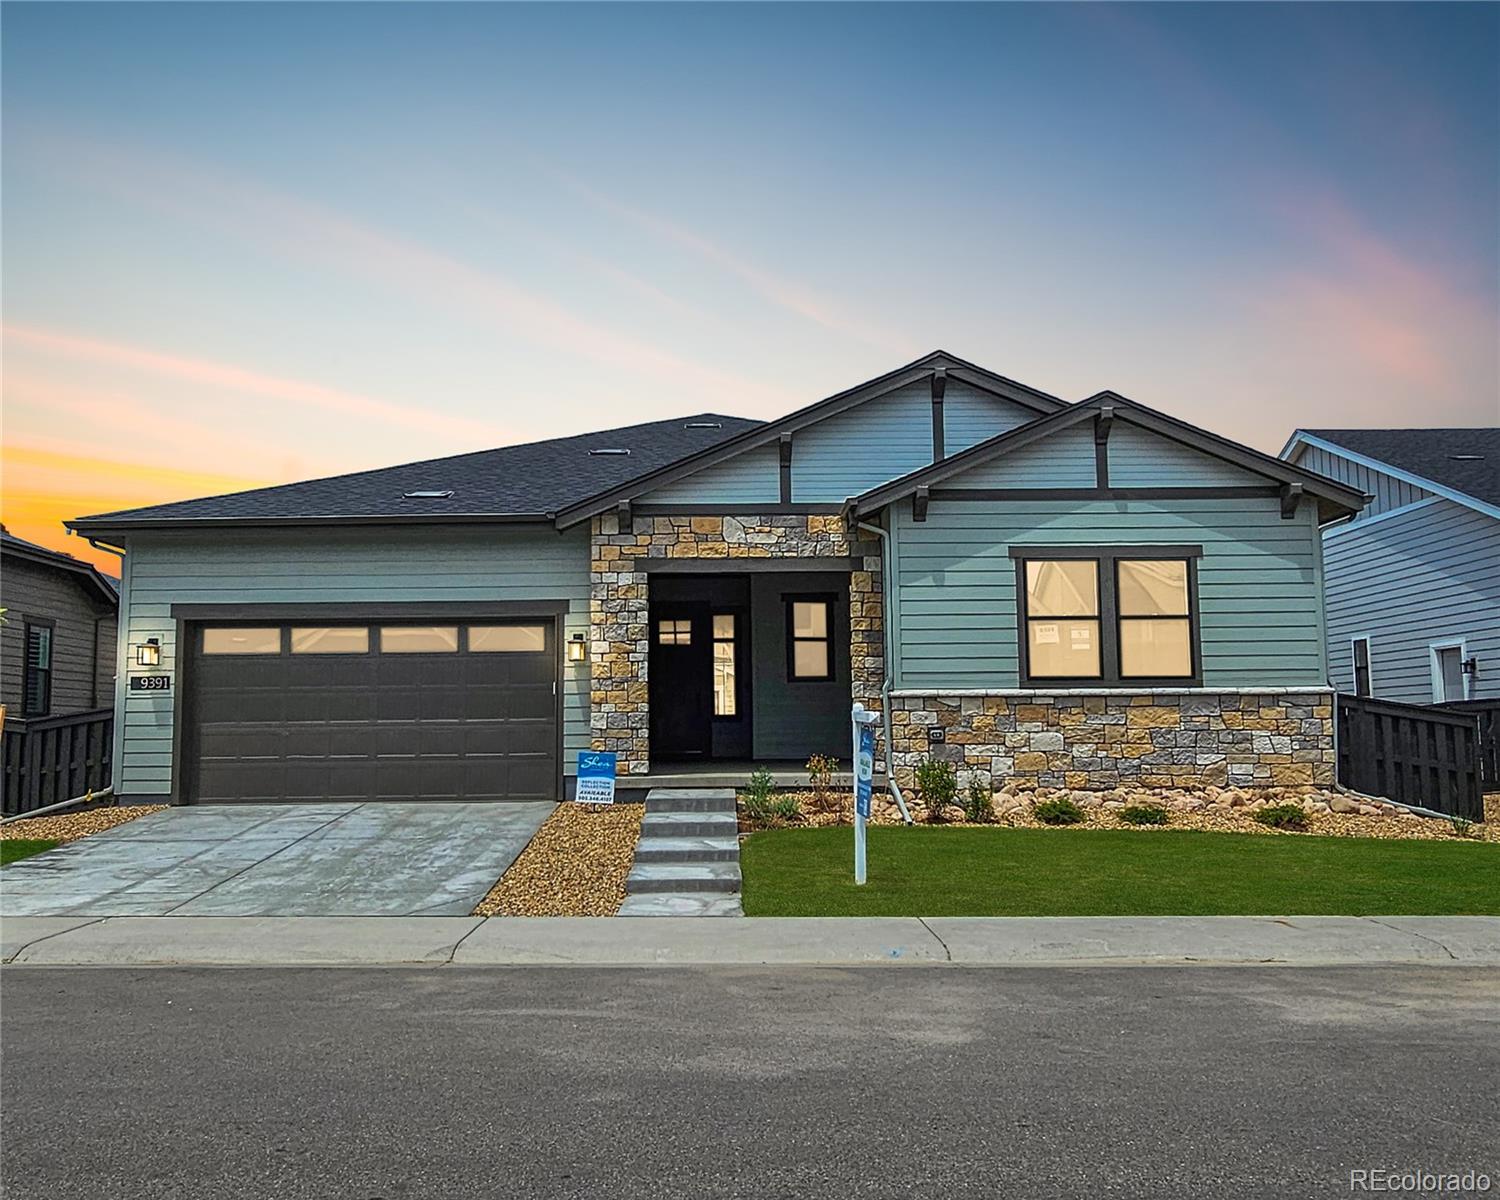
<box><xmin>741</xmin><ymin>788</ymin><xmax>1500</xmax><ymax>843</ymax></box>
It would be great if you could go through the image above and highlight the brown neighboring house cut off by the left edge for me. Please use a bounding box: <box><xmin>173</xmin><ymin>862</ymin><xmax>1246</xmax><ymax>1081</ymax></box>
<box><xmin>0</xmin><ymin>527</ymin><xmax>120</xmax><ymax>719</ymax></box>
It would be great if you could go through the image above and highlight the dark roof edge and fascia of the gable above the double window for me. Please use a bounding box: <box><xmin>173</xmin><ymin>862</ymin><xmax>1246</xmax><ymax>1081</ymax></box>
<box><xmin>854</xmin><ymin>392</ymin><xmax>1364</xmax><ymax>521</ymax></box>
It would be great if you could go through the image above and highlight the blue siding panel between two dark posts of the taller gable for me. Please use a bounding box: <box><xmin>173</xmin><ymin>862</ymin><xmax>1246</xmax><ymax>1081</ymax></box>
<box><xmin>792</xmin><ymin>381</ymin><xmax>933</xmax><ymax>504</ymax></box>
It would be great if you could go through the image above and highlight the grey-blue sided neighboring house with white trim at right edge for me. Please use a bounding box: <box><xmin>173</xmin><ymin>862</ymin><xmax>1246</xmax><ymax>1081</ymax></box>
<box><xmin>1281</xmin><ymin>428</ymin><xmax>1500</xmax><ymax>704</ymax></box>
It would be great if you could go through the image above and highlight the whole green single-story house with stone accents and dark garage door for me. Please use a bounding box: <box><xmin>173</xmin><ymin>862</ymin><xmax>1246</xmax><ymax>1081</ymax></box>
<box><xmin>71</xmin><ymin>353</ymin><xmax>1364</xmax><ymax>803</ymax></box>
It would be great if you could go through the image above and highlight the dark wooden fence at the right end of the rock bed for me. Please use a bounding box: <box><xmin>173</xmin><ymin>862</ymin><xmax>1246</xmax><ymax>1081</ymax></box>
<box><xmin>1338</xmin><ymin>695</ymin><xmax>1485</xmax><ymax>821</ymax></box>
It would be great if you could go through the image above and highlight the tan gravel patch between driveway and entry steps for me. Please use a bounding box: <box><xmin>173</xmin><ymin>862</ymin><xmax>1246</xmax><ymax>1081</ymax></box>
<box><xmin>474</xmin><ymin>804</ymin><xmax>645</xmax><ymax>917</ymax></box>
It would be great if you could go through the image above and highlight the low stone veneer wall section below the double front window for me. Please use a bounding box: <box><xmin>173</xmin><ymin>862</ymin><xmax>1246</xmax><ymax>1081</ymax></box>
<box><xmin>891</xmin><ymin>690</ymin><xmax>1335</xmax><ymax>789</ymax></box>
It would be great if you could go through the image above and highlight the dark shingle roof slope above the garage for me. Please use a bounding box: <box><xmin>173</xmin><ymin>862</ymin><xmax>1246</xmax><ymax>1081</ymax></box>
<box><xmin>75</xmin><ymin>413</ymin><xmax>762</xmax><ymax>528</ymax></box>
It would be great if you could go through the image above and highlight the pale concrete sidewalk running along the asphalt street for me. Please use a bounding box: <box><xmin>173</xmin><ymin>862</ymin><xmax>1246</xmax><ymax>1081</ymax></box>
<box><xmin>0</xmin><ymin>917</ymin><xmax>1500</xmax><ymax>966</ymax></box>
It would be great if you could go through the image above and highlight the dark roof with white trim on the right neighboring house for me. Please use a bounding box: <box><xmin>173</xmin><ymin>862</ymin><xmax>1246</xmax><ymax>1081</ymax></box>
<box><xmin>1281</xmin><ymin>426</ymin><xmax>1500</xmax><ymax>518</ymax></box>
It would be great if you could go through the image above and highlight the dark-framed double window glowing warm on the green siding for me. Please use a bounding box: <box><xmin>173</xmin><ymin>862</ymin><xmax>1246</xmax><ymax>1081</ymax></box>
<box><xmin>1011</xmin><ymin>546</ymin><xmax>1199</xmax><ymax>686</ymax></box>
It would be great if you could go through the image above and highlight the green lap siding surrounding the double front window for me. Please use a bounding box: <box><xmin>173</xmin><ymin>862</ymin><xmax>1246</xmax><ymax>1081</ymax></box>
<box><xmin>896</xmin><ymin>498</ymin><xmax>1325</xmax><ymax>689</ymax></box>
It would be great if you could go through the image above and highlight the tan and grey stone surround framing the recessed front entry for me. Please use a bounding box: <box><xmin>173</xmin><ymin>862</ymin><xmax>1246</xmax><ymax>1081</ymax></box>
<box><xmin>588</xmin><ymin>515</ymin><xmax>885</xmax><ymax>776</ymax></box>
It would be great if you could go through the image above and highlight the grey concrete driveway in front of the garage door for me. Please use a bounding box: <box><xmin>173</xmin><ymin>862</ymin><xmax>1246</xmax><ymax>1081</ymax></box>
<box><xmin>0</xmin><ymin>804</ymin><xmax>554</xmax><ymax>917</ymax></box>
